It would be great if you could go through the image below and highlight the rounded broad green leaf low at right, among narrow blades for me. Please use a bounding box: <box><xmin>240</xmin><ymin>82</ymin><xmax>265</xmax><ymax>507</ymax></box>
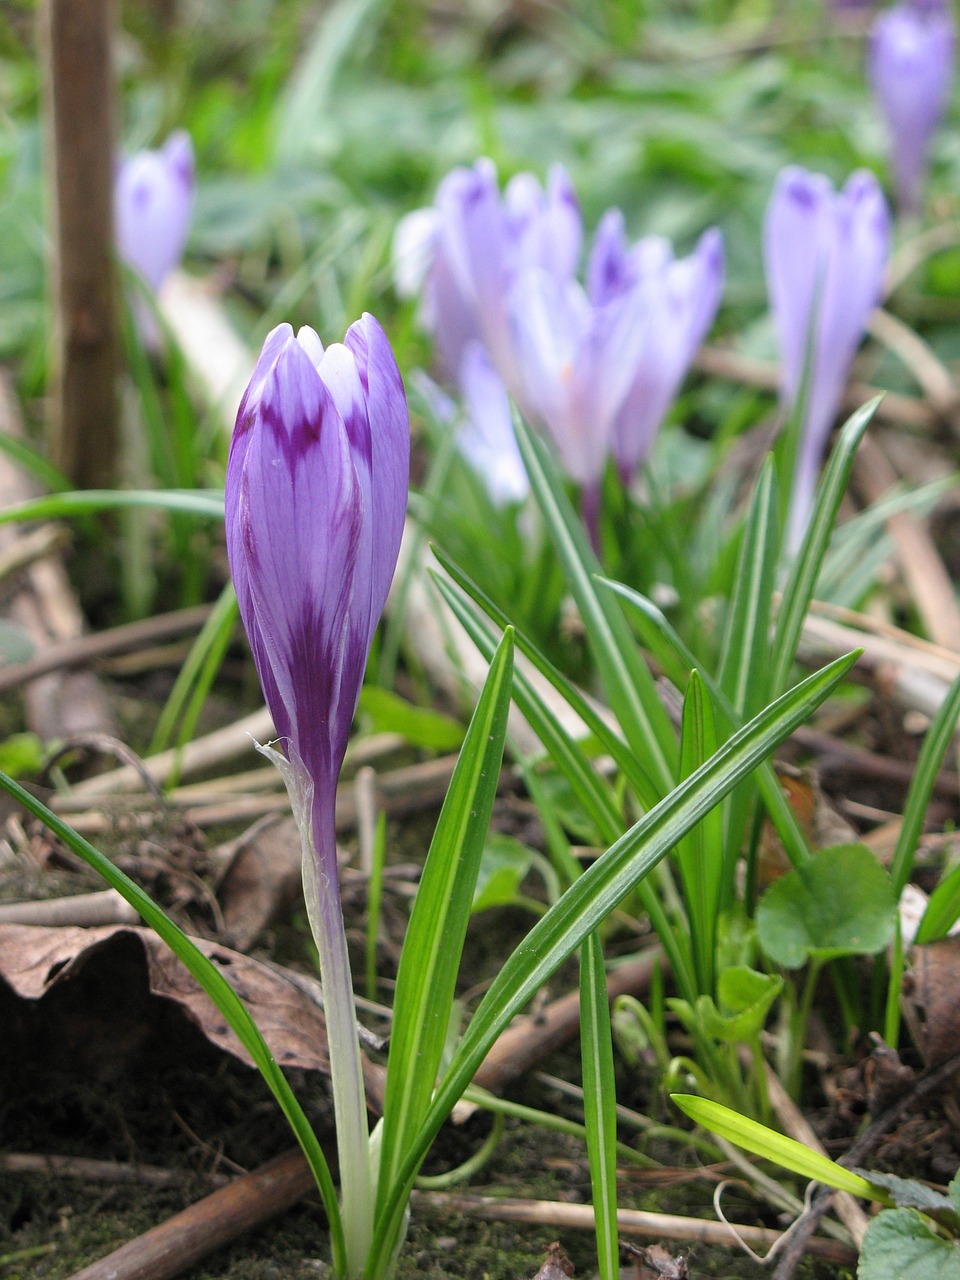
<box><xmin>756</xmin><ymin>845</ymin><xmax>896</xmax><ymax>969</ymax></box>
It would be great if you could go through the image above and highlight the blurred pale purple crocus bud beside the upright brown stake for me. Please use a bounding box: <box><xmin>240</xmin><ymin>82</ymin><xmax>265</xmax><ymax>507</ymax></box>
<box><xmin>114</xmin><ymin>129</ymin><xmax>196</xmax><ymax>346</ymax></box>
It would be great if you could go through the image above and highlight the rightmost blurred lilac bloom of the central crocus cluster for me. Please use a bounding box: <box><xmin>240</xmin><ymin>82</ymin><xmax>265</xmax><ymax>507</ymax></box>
<box><xmin>588</xmin><ymin>209</ymin><xmax>723</xmax><ymax>484</ymax></box>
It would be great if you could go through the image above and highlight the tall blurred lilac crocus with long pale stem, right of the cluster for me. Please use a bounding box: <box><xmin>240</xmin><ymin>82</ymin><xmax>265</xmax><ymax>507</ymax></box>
<box><xmin>764</xmin><ymin>166</ymin><xmax>891</xmax><ymax>548</ymax></box>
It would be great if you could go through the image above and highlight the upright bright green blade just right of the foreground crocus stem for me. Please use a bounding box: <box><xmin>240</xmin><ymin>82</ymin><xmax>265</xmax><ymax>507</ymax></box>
<box><xmin>378</xmin><ymin>630</ymin><xmax>513</xmax><ymax>1228</ymax></box>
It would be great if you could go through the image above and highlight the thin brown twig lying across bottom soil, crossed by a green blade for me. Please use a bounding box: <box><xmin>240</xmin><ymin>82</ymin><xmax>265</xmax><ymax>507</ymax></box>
<box><xmin>413</xmin><ymin>1192</ymin><xmax>856</xmax><ymax>1265</ymax></box>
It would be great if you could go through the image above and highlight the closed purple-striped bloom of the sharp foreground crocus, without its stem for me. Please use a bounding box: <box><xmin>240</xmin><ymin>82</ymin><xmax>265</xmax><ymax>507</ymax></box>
<box><xmin>225</xmin><ymin>316</ymin><xmax>410</xmax><ymax>809</ymax></box>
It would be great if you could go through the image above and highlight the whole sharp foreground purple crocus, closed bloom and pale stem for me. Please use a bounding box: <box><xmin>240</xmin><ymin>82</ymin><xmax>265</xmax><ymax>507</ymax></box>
<box><xmin>225</xmin><ymin>315</ymin><xmax>410</xmax><ymax>1271</ymax></box>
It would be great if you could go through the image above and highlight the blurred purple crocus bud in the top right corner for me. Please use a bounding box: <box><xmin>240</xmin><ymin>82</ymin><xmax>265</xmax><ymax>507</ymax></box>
<box><xmin>867</xmin><ymin>0</ymin><xmax>956</xmax><ymax>211</ymax></box>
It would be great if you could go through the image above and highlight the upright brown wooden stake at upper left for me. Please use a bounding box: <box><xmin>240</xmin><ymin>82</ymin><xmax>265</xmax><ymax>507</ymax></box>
<box><xmin>41</xmin><ymin>0</ymin><xmax>119</xmax><ymax>488</ymax></box>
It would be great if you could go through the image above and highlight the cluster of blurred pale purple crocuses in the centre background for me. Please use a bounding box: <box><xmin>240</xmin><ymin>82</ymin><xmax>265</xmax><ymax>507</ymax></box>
<box><xmin>394</xmin><ymin>160</ymin><xmax>723</xmax><ymax>519</ymax></box>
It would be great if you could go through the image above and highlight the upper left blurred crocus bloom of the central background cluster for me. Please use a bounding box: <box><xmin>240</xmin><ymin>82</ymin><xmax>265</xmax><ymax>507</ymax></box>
<box><xmin>394</xmin><ymin>159</ymin><xmax>582</xmax><ymax>390</ymax></box>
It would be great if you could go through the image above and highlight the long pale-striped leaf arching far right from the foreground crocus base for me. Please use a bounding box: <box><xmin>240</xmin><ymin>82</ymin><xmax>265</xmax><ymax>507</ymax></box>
<box><xmin>370</xmin><ymin>653</ymin><xmax>859</xmax><ymax>1275</ymax></box>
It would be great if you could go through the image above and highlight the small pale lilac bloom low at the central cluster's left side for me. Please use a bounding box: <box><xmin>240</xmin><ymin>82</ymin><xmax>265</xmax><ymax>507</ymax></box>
<box><xmin>457</xmin><ymin>342</ymin><xmax>530</xmax><ymax>507</ymax></box>
